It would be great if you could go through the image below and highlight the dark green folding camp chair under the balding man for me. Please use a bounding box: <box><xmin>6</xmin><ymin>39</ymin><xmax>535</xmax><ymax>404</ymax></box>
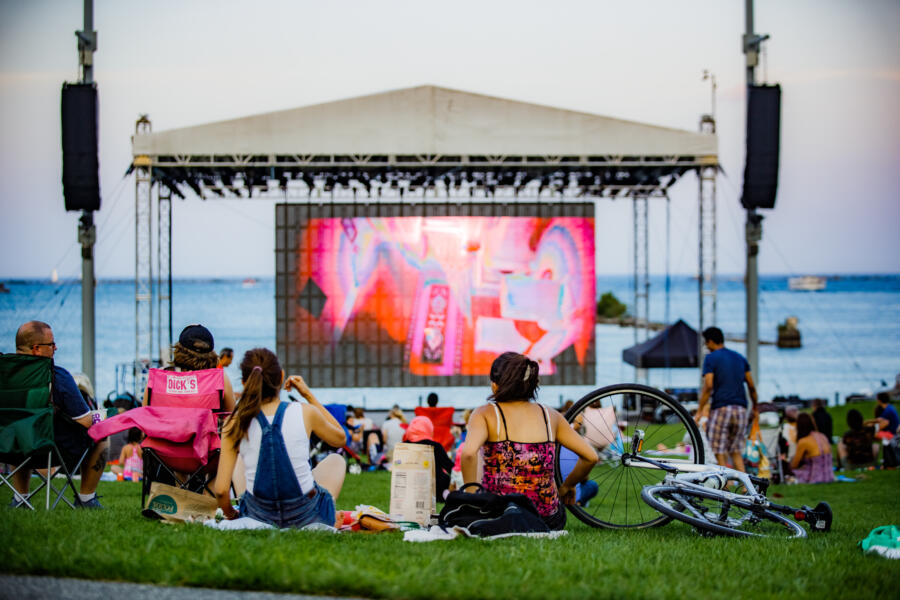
<box><xmin>0</xmin><ymin>354</ymin><xmax>90</xmax><ymax>510</ymax></box>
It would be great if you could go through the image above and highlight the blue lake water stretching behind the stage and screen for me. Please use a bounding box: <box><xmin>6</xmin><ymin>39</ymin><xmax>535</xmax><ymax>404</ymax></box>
<box><xmin>0</xmin><ymin>275</ymin><xmax>900</xmax><ymax>408</ymax></box>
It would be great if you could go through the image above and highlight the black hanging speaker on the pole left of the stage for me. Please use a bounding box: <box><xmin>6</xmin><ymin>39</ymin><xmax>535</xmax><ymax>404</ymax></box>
<box><xmin>61</xmin><ymin>83</ymin><xmax>100</xmax><ymax>210</ymax></box>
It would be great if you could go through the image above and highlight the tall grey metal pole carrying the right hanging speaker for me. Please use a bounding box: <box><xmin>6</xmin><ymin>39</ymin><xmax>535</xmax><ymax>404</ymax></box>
<box><xmin>744</xmin><ymin>0</ymin><xmax>764</xmax><ymax>385</ymax></box>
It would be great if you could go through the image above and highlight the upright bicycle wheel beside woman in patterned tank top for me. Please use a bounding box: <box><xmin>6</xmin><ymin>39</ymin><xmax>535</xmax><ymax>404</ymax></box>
<box><xmin>556</xmin><ymin>384</ymin><xmax>704</xmax><ymax>529</ymax></box>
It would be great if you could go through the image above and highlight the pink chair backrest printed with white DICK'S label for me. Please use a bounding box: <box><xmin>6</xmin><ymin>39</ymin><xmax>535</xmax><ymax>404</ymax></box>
<box><xmin>147</xmin><ymin>369</ymin><xmax>225</xmax><ymax>412</ymax></box>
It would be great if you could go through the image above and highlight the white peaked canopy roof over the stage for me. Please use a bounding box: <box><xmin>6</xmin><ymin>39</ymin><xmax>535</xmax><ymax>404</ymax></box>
<box><xmin>133</xmin><ymin>85</ymin><xmax>717</xmax><ymax>159</ymax></box>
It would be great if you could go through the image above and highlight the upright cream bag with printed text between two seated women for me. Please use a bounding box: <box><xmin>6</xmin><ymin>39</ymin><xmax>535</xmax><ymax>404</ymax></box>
<box><xmin>390</xmin><ymin>442</ymin><xmax>437</xmax><ymax>526</ymax></box>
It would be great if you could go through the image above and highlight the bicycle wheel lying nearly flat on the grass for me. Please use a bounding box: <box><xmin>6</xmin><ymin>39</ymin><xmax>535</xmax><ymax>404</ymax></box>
<box><xmin>641</xmin><ymin>485</ymin><xmax>806</xmax><ymax>538</ymax></box>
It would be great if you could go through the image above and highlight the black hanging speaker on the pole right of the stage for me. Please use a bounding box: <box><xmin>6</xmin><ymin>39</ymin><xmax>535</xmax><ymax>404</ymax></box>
<box><xmin>741</xmin><ymin>85</ymin><xmax>781</xmax><ymax>209</ymax></box>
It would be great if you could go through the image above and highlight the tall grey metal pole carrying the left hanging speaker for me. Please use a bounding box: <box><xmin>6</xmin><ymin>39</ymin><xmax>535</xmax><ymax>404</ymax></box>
<box><xmin>75</xmin><ymin>0</ymin><xmax>97</xmax><ymax>387</ymax></box>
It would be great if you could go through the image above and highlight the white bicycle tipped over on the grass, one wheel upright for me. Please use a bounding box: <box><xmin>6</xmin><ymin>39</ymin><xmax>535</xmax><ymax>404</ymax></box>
<box><xmin>557</xmin><ymin>384</ymin><xmax>833</xmax><ymax>538</ymax></box>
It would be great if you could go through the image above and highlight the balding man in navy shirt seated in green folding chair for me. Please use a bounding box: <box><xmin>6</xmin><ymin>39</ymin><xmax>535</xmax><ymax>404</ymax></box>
<box><xmin>13</xmin><ymin>321</ymin><xmax>107</xmax><ymax>508</ymax></box>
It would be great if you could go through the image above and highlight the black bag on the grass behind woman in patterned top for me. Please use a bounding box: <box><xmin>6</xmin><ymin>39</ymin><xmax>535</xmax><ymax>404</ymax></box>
<box><xmin>438</xmin><ymin>483</ymin><xmax>550</xmax><ymax>537</ymax></box>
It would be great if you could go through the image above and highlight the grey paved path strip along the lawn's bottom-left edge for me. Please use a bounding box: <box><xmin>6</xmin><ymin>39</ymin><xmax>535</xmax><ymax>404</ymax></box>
<box><xmin>0</xmin><ymin>575</ymin><xmax>366</xmax><ymax>600</ymax></box>
